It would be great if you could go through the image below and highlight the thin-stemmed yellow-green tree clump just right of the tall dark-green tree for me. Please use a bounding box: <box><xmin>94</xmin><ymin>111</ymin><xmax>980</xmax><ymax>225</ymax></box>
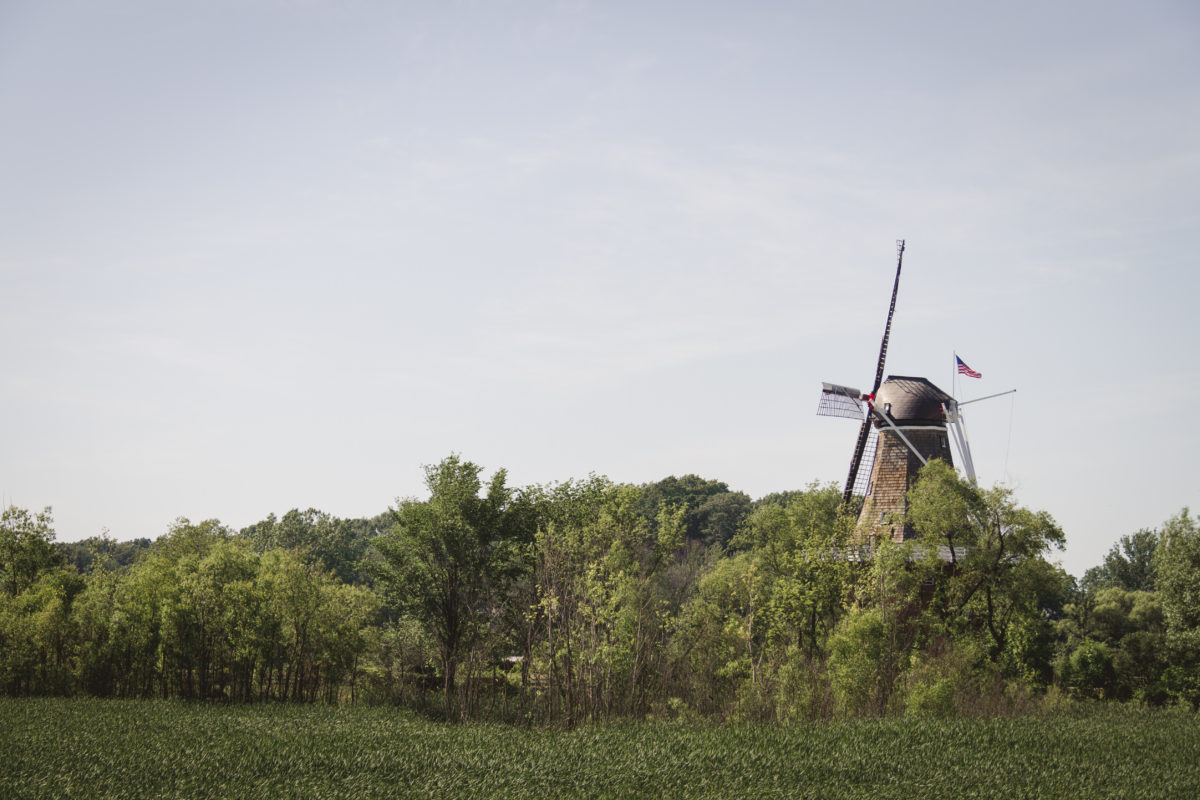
<box><xmin>534</xmin><ymin>479</ymin><xmax>685</xmax><ymax>726</ymax></box>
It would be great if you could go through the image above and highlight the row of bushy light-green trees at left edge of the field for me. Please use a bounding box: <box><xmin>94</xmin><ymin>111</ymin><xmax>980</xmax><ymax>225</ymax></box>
<box><xmin>0</xmin><ymin>519</ymin><xmax>378</xmax><ymax>700</ymax></box>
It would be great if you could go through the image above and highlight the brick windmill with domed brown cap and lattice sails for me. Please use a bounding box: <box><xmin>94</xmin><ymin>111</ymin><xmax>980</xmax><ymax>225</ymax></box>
<box><xmin>817</xmin><ymin>240</ymin><xmax>974</xmax><ymax>542</ymax></box>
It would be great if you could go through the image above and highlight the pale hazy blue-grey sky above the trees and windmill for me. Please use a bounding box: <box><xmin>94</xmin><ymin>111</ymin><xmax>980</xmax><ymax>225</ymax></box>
<box><xmin>0</xmin><ymin>0</ymin><xmax>1200</xmax><ymax>575</ymax></box>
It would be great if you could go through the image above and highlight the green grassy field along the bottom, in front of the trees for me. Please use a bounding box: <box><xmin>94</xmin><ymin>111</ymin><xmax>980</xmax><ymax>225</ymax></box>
<box><xmin>0</xmin><ymin>699</ymin><xmax>1200</xmax><ymax>800</ymax></box>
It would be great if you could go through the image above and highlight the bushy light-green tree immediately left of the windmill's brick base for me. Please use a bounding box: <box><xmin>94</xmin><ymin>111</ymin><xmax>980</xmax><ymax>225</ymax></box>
<box><xmin>674</xmin><ymin>485</ymin><xmax>853</xmax><ymax>718</ymax></box>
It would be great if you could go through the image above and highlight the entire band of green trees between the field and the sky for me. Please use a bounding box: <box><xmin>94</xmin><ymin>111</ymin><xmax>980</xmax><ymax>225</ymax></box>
<box><xmin>0</xmin><ymin>456</ymin><xmax>1200</xmax><ymax>726</ymax></box>
